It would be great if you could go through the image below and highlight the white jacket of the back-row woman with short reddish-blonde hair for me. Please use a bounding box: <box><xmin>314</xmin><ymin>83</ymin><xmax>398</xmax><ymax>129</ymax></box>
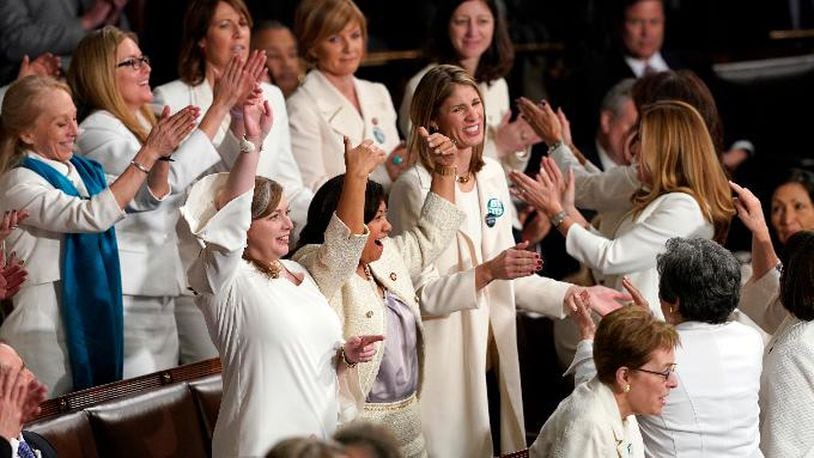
<box><xmin>288</xmin><ymin>69</ymin><xmax>400</xmax><ymax>191</ymax></box>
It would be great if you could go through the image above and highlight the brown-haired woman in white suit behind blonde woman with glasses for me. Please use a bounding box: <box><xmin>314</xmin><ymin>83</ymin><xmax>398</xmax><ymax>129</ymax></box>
<box><xmin>154</xmin><ymin>0</ymin><xmax>313</xmax><ymax>362</ymax></box>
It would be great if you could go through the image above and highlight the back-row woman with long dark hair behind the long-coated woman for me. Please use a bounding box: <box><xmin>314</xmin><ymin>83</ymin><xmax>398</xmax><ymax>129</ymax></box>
<box><xmin>399</xmin><ymin>0</ymin><xmax>540</xmax><ymax>171</ymax></box>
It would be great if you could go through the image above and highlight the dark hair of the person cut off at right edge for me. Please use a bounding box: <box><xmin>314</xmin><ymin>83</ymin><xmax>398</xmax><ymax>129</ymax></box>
<box><xmin>780</xmin><ymin>231</ymin><xmax>814</xmax><ymax>321</ymax></box>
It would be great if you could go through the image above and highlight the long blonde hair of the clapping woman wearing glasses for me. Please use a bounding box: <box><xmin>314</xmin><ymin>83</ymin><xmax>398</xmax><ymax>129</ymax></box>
<box><xmin>68</xmin><ymin>25</ymin><xmax>156</xmax><ymax>143</ymax></box>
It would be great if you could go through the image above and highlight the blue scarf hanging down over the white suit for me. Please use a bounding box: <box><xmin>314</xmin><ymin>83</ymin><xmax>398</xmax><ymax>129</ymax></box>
<box><xmin>22</xmin><ymin>154</ymin><xmax>124</xmax><ymax>390</ymax></box>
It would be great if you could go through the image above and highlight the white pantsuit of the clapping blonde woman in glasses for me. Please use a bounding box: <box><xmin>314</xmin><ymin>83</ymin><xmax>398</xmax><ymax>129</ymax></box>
<box><xmin>77</xmin><ymin>110</ymin><xmax>221</xmax><ymax>372</ymax></box>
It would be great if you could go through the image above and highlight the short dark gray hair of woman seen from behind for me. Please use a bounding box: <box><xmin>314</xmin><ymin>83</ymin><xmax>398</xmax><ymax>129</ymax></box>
<box><xmin>656</xmin><ymin>237</ymin><xmax>741</xmax><ymax>324</ymax></box>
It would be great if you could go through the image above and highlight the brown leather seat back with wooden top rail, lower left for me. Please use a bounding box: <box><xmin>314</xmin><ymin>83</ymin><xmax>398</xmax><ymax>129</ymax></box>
<box><xmin>25</xmin><ymin>358</ymin><xmax>222</xmax><ymax>458</ymax></box>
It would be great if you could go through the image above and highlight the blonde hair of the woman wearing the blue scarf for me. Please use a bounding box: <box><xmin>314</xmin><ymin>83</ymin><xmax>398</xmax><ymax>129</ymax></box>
<box><xmin>0</xmin><ymin>75</ymin><xmax>71</xmax><ymax>175</ymax></box>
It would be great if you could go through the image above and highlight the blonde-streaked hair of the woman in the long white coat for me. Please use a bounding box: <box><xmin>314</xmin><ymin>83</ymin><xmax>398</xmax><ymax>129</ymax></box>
<box><xmin>407</xmin><ymin>65</ymin><xmax>486</xmax><ymax>173</ymax></box>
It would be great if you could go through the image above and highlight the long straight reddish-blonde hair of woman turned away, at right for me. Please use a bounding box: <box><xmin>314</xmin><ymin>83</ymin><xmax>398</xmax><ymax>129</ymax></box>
<box><xmin>632</xmin><ymin>100</ymin><xmax>735</xmax><ymax>243</ymax></box>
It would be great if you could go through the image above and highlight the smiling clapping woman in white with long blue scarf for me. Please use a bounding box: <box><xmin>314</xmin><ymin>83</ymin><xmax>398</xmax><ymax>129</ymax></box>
<box><xmin>0</xmin><ymin>76</ymin><xmax>195</xmax><ymax>396</ymax></box>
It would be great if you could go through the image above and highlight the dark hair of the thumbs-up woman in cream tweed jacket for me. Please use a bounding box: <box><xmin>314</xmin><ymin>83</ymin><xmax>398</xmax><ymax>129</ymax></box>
<box><xmin>292</xmin><ymin>173</ymin><xmax>387</xmax><ymax>253</ymax></box>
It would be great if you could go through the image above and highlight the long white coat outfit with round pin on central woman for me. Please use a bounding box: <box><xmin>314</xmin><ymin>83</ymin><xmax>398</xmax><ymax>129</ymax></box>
<box><xmin>388</xmin><ymin>158</ymin><xmax>571</xmax><ymax>457</ymax></box>
